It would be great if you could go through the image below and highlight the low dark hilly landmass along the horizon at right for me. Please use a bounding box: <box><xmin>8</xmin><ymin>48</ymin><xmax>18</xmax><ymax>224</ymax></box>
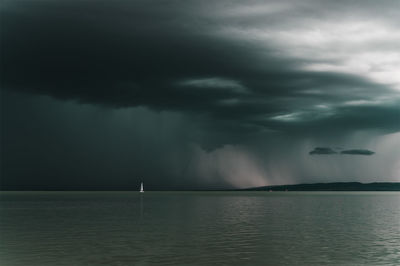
<box><xmin>242</xmin><ymin>182</ymin><xmax>400</xmax><ymax>191</ymax></box>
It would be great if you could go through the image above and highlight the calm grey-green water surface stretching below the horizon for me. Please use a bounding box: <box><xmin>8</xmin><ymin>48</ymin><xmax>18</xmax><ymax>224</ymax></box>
<box><xmin>0</xmin><ymin>192</ymin><xmax>400</xmax><ymax>266</ymax></box>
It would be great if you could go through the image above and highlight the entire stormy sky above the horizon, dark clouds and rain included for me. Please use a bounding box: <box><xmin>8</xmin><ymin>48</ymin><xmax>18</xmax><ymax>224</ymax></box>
<box><xmin>0</xmin><ymin>0</ymin><xmax>400</xmax><ymax>190</ymax></box>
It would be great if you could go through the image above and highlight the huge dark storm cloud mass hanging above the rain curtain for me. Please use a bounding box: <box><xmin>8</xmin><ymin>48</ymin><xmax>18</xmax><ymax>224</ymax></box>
<box><xmin>1</xmin><ymin>1</ymin><xmax>400</xmax><ymax>138</ymax></box>
